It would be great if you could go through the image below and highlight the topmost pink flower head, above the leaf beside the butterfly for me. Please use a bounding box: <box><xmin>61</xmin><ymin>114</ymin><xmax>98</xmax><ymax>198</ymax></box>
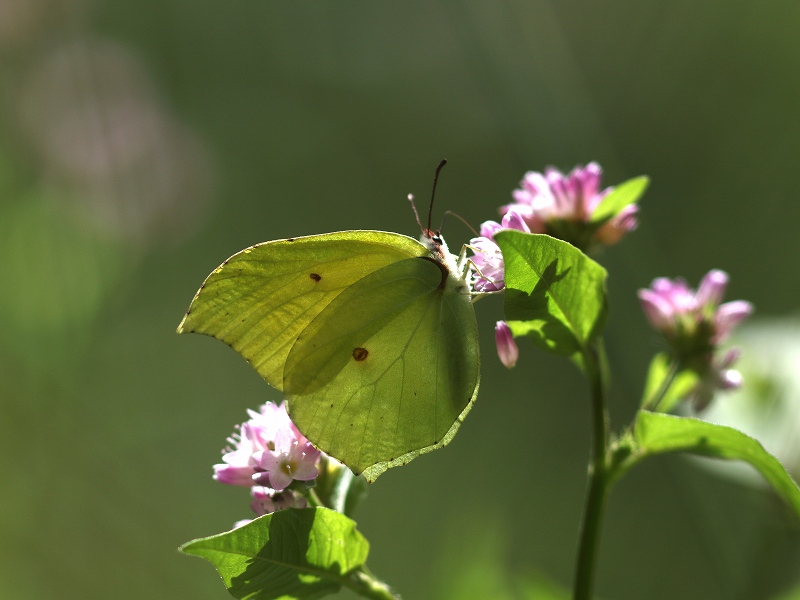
<box><xmin>500</xmin><ymin>162</ymin><xmax>639</xmax><ymax>249</ymax></box>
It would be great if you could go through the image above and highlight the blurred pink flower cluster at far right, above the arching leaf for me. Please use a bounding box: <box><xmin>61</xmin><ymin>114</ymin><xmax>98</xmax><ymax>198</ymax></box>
<box><xmin>639</xmin><ymin>270</ymin><xmax>753</xmax><ymax>410</ymax></box>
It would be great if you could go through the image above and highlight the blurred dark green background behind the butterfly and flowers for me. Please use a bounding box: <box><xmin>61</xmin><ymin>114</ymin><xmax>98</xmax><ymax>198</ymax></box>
<box><xmin>0</xmin><ymin>0</ymin><xmax>800</xmax><ymax>600</ymax></box>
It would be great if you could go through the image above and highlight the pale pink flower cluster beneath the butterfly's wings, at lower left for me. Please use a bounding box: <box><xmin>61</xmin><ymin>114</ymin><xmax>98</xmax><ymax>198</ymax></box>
<box><xmin>214</xmin><ymin>402</ymin><xmax>321</xmax><ymax>515</ymax></box>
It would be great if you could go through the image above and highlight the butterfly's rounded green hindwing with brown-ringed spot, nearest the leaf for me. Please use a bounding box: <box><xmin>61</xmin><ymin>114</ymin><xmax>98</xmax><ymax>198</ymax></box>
<box><xmin>283</xmin><ymin>258</ymin><xmax>479</xmax><ymax>480</ymax></box>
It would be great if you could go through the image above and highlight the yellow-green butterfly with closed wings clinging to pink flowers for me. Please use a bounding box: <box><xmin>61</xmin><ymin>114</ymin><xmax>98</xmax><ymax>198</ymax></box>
<box><xmin>178</xmin><ymin>165</ymin><xmax>480</xmax><ymax>481</ymax></box>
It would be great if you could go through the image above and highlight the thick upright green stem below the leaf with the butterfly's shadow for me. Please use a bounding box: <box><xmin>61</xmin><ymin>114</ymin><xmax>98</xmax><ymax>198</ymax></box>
<box><xmin>572</xmin><ymin>342</ymin><xmax>609</xmax><ymax>600</ymax></box>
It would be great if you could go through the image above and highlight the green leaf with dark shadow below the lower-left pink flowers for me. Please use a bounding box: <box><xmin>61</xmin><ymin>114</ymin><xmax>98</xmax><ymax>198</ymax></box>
<box><xmin>180</xmin><ymin>508</ymin><xmax>369</xmax><ymax>600</ymax></box>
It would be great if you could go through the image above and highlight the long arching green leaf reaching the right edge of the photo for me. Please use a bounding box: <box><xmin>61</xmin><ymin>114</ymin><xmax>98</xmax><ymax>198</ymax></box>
<box><xmin>634</xmin><ymin>411</ymin><xmax>800</xmax><ymax>518</ymax></box>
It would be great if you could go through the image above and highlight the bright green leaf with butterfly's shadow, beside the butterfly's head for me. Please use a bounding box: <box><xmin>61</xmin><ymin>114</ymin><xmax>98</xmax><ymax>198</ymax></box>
<box><xmin>495</xmin><ymin>230</ymin><xmax>608</xmax><ymax>355</ymax></box>
